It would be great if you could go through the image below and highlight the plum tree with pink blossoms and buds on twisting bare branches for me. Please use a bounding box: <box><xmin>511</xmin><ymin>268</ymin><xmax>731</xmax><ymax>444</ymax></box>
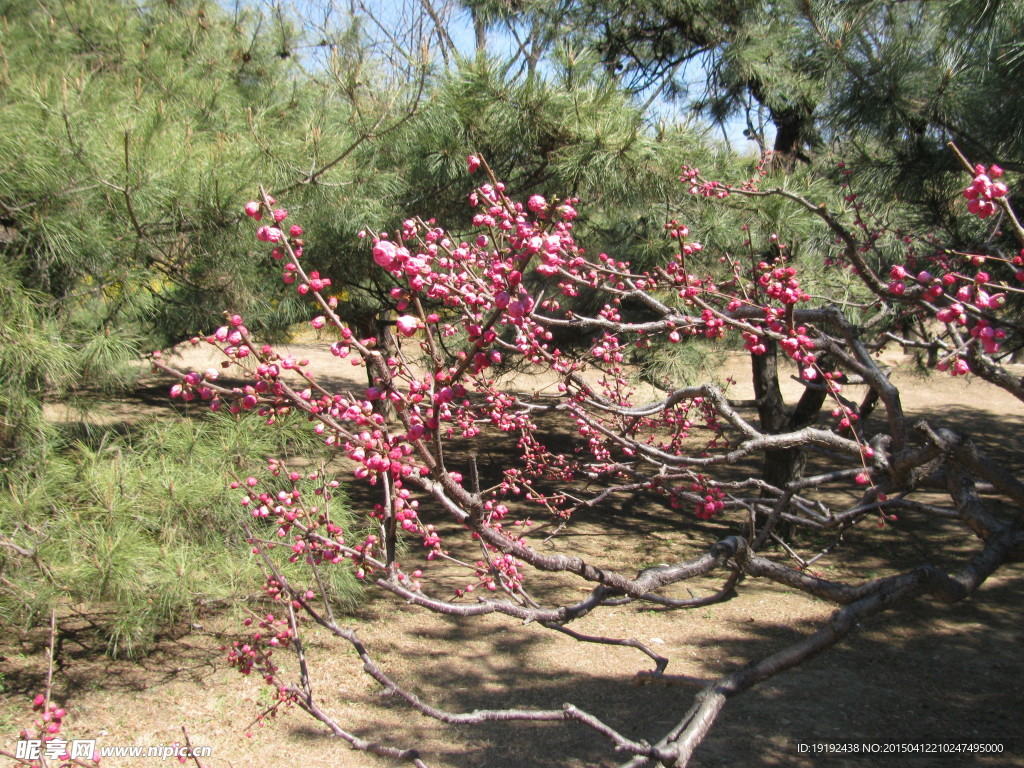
<box><xmin>153</xmin><ymin>145</ymin><xmax>1024</xmax><ymax>766</ymax></box>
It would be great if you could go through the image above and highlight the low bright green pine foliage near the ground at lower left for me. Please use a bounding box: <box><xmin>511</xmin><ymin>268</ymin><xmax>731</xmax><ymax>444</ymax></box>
<box><xmin>0</xmin><ymin>415</ymin><xmax>358</xmax><ymax>655</ymax></box>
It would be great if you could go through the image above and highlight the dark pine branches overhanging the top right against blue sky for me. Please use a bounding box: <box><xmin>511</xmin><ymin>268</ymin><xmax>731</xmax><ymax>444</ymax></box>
<box><xmin>548</xmin><ymin>0</ymin><xmax>1024</xmax><ymax>180</ymax></box>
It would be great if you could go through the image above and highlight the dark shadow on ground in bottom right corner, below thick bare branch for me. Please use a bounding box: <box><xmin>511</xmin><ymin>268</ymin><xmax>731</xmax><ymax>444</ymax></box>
<box><xmin>694</xmin><ymin>568</ymin><xmax>1024</xmax><ymax>768</ymax></box>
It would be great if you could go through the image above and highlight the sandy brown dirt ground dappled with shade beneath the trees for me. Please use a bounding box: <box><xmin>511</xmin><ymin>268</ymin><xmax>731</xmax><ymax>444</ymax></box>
<box><xmin>8</xmin><ymin>345</ymin><xmax>1024</xmax><ymax>768</ymax></box>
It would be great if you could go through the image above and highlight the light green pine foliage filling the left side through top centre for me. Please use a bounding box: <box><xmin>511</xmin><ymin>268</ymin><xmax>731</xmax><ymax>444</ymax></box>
<box><xmin>0</xmin><ymin>0</ymin><xmax>729</xmax><ymax>653</ymax></box>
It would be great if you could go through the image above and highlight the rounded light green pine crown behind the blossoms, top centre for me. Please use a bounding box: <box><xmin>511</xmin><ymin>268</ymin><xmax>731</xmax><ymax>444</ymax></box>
<box><xmin>389</xmin><ymin>49</ymin><xmax>697</xmax><ymax>220</ymax></box>
